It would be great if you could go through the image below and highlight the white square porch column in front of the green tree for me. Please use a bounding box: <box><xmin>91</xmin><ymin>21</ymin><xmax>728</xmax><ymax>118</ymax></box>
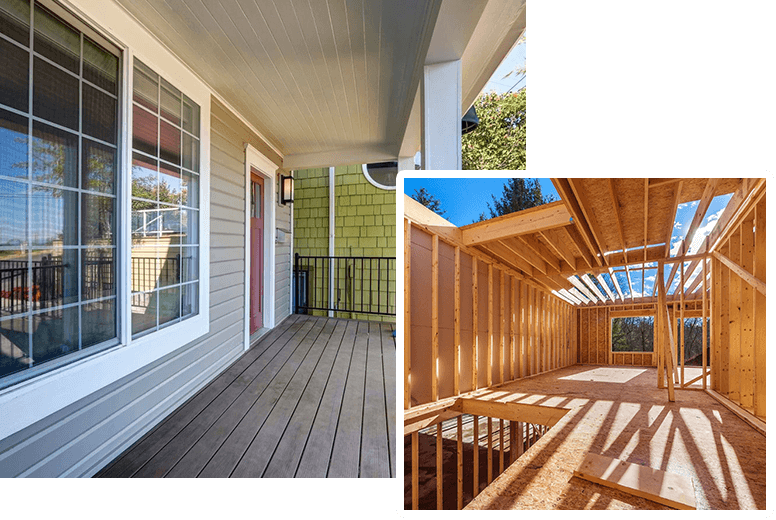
<box><xmin>420</xmin><ymin>60</ymin><xmax>461</xmax><ymax>170</ymax></box>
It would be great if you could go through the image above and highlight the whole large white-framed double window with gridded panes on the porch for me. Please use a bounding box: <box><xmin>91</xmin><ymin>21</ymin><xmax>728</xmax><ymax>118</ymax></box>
<box><xmin>0</xmin><ymin>0</ymin><xmax>211</xmax><ymax>438</ymax></box>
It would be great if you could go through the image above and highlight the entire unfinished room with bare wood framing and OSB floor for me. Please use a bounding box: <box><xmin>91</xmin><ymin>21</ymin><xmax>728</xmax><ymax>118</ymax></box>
<box><xmin>399</xmin><ymin>177</ymin><xmax>773</xmax><ymax>510</ymax></box>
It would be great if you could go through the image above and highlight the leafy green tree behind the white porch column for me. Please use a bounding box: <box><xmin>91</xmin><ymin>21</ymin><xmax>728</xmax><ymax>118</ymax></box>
<box><xmin>461</xmin><ymin>88</ymin><xmax>526</xmax><ymax>170</ymax></box>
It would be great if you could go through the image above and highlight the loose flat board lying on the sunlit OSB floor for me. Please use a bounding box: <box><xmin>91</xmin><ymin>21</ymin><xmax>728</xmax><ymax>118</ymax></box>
<box><xmin>574</xmin><ymin>453</ymin><xmax>695</xmax><ymax>510</ymax></box>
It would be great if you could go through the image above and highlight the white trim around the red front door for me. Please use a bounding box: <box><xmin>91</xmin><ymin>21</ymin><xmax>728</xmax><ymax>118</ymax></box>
<box><xmin>243</xmin><ymin>143</ymin><xmax>280</xmax><ymax>350</ymax></box>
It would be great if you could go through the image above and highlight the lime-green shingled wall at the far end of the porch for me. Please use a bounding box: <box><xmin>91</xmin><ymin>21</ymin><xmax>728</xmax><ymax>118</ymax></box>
<box><xmin>294</xmin><ymin>165</ymin><xmax>396</xmax><ymax>322</ymax></box>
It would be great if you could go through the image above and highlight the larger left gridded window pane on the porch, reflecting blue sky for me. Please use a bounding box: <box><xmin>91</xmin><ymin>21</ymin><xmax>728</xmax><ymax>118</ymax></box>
<box><xmin>0</xmin><ymin>0</ymin><xmax>119</xmax><ymax>378</ymax></box>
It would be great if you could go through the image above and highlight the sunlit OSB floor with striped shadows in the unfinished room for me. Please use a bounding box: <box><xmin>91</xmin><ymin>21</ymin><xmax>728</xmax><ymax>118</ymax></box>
<box><xmin>465</xmin><ymin>365</ymin><xmax>766</xmax><ymax>510</ymax></box>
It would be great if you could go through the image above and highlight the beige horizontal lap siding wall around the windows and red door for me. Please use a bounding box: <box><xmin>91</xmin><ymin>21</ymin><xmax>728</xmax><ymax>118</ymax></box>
<box><xmin>0</xmin><ymin>25</ymin><xmax>292</xmax><ymax>477</ymax></box>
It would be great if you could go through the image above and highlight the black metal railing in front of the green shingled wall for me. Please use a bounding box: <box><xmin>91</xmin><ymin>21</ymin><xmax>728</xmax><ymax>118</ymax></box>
<box><xmin>294</xmin><ymin>254</ymin><xmax>396</xmax><ymax>316</ymax></box>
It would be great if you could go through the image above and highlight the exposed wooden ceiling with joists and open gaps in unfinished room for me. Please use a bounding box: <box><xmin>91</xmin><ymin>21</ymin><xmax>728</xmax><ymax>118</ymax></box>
<box><xmin>460</xmin><ymin>177</ymin><xmax>756</xmax><ymax>305</ymax></box>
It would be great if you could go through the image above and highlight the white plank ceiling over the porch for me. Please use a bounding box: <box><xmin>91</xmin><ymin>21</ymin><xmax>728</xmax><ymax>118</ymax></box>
<box><xmin>116</xmin><ymin>0</ymin><xmax>525</xmax><ymax>169</ymax></box>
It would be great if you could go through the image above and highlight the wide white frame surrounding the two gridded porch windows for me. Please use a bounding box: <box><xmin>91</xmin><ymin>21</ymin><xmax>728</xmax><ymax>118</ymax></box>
<box><xmin>0</xmin><ymin>0</ymin><xmax>211</xmax><ymax>439</ymax></box>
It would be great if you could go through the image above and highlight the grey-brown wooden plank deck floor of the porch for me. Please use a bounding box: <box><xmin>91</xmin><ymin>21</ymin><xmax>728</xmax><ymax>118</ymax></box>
<box><xmin>96</xmin><ymin>315</ymin><xmax>396</xmax><ymax>477</ymax></box>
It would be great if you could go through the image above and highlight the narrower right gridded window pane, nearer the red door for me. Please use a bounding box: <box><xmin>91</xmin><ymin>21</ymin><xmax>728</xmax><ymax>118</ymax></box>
<box><xmin>131</xmin><ymin>60</ymin><xmax>200</xmax><ymax>336</ymax></box>
